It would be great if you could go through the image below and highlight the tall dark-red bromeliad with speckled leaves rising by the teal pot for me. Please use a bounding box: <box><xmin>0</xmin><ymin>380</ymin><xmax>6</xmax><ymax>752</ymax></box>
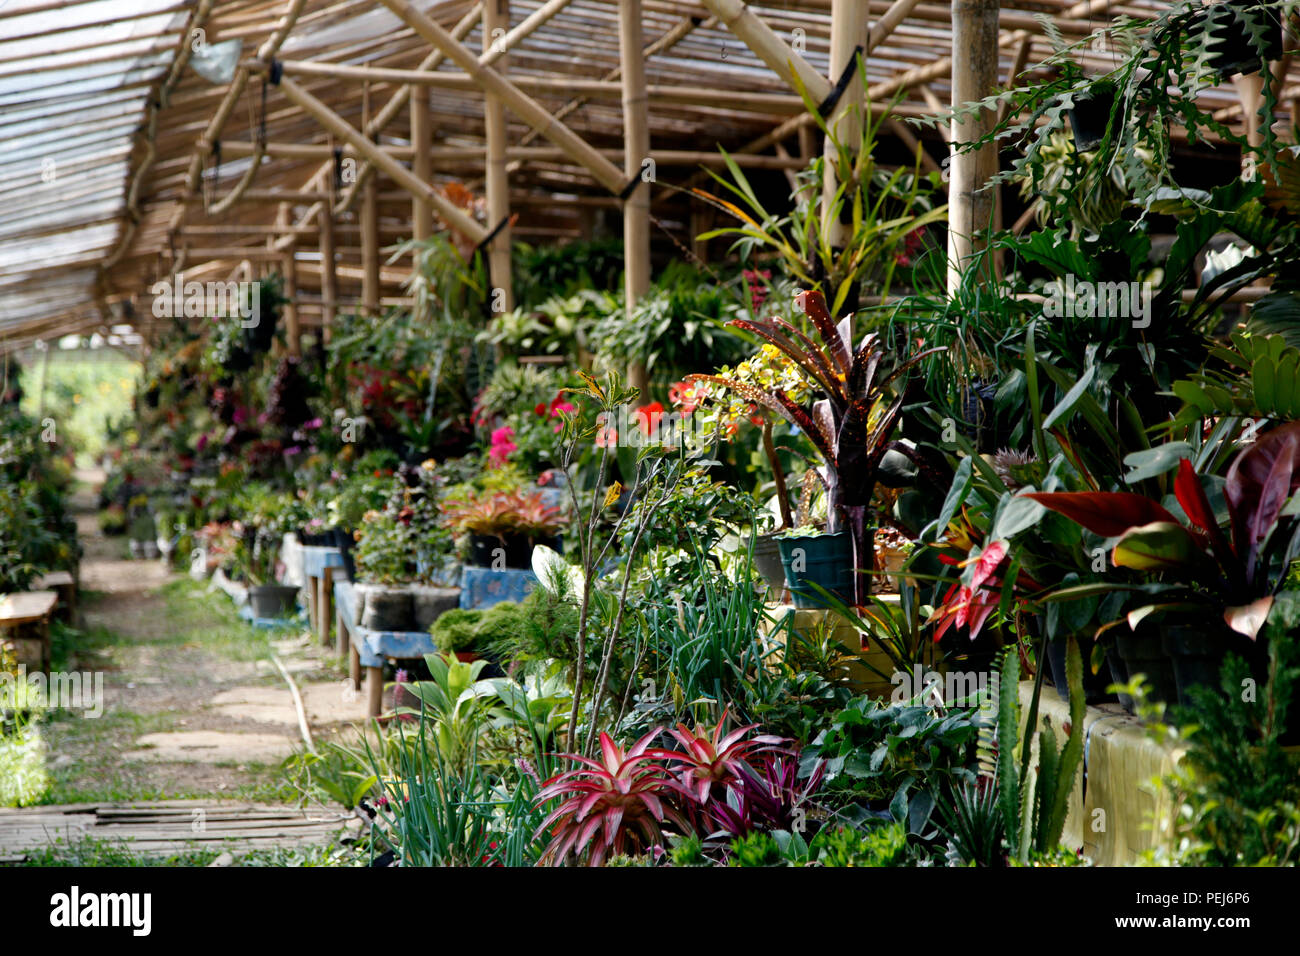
<box><xmin>688</xmin><ymin>291</ymin><xmax>941</xmax><ymax>605</ymax></box>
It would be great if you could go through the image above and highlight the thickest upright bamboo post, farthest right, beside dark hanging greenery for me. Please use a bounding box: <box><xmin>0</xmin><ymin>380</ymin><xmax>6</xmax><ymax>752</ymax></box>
<box><xmin>948</xmin><ymin>0</ymin><xmax>998</xmax><ymax>294</ymax></box>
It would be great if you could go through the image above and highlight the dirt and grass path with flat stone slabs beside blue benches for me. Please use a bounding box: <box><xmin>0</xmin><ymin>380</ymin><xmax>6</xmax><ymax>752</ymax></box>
<box><xmin>44</xmin><ymin>472</ymin><xmax>364</xmax><ymax>804</ymax></box>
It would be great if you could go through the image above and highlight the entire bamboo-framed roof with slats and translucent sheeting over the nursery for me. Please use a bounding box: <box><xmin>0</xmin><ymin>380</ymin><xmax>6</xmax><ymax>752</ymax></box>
<box><xmin>0</xmin><ymin>0</ymin><xmax>1300</xmax><ymax>350</ymax></box>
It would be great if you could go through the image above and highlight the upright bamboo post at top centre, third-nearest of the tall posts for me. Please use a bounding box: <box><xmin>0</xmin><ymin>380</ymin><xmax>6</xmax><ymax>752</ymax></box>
<box><xmin>619</xmin><ymin>0</ymin><xmax>653</xmax><ymax>402</ymax></box>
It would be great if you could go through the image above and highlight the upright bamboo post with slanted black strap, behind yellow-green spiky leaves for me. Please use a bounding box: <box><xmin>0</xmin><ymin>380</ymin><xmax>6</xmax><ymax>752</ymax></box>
<box><xmin>822</xmin><ymin>0</ymin><xmax>871</xmax><ymax>311</ymax></box>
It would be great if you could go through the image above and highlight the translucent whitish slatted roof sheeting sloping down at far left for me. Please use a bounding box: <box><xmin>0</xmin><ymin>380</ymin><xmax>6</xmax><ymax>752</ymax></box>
<box><xmin>0</xmin><ymin>0</ymin><xmax>190</xmax><ymax>345</ymax></box>
